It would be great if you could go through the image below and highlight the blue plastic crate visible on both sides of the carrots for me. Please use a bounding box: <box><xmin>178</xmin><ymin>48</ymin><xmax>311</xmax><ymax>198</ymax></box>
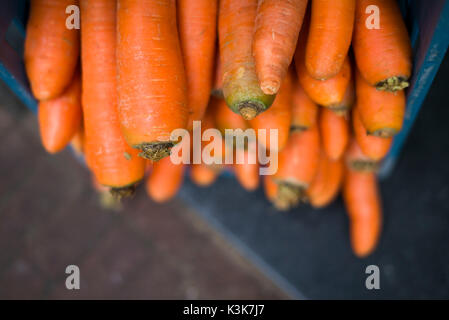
<box><xmin>0</xmin><ymin>0</ymin><xmax>449</xmax><ymax>178</ymax></box>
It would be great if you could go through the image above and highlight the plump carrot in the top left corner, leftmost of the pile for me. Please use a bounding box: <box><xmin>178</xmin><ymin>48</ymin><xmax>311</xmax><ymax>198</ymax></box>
<box><xmin>24</xmin><ymin>0</ymin><xmax>79</xmax><ymax>100</ymax></box>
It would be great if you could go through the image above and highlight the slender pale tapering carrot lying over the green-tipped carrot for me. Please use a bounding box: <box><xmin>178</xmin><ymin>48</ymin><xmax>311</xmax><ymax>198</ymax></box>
<box><xmin>253</xmin><ymin>0</ymin><xmax>307</xmax><ymax>94</ymax></box>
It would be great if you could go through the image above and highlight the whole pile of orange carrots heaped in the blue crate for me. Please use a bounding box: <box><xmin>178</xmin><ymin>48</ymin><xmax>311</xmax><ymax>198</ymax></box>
<box><xmin>25</xmin><ymin>0</ymin><xmax>411</xmax><ymax>256</ymax></box>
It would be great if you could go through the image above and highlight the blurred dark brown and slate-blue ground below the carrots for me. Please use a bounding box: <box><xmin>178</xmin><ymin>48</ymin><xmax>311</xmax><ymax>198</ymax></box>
<box><xmin>0</xmin><ymin>48</ymin><xmax>449</xmax><ymax>299</ymax></box>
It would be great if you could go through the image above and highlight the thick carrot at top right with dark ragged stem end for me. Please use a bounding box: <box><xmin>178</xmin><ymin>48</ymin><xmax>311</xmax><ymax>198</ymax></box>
<box><xmin>353</xmin><ymin>0</ymin><xmax>412</xmax><ymax>91</ymax></box>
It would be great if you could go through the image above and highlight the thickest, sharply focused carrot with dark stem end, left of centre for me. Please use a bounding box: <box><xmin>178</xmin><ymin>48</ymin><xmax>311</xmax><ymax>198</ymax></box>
<box><xmin>117</xmin><ymin>0</ymin><xmax>188</xmax><ymax>161</ymax></box>
